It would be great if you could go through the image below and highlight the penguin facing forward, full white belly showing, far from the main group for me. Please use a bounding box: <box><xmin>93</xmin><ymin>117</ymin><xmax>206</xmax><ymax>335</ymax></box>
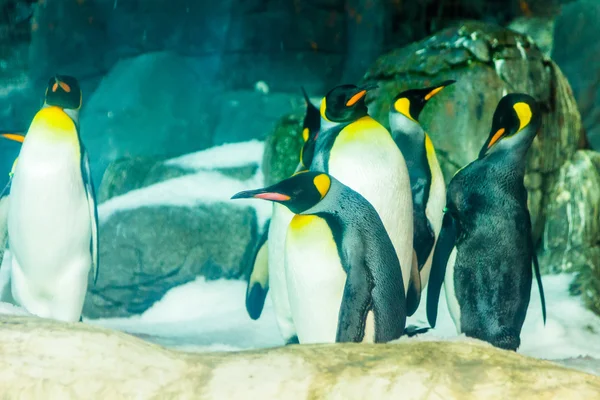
<box><xmin>8</xmin><ymin>75</ymin><xmax>98</xmax><ymax>321</ymax></box>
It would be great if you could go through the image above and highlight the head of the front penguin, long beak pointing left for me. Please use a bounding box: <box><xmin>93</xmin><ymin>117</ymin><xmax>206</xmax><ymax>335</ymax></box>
<box><xmin>232</xmin><ymin>171</ymin><xmax>332</xmax><ymax>214</ymax></box>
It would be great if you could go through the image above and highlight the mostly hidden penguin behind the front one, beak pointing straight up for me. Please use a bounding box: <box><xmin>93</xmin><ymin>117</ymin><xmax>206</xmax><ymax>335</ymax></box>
<box><xmin>246</xmin><ymin>88</ymin><xmax>321</xmax><ymax>344</ymax></box>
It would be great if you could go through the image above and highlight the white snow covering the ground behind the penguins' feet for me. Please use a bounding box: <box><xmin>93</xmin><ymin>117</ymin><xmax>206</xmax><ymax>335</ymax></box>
<box><xmin>86</xmin><ymin>274</ymin><xmax>600</xmax><ymax>360</ymax></box>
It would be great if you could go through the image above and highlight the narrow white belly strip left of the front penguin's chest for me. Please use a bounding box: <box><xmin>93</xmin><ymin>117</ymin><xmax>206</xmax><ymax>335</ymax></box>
<box><xmin>268</xmin><ymin>203</ymin><xmax>296</xmax><ymax>341</ymax></box>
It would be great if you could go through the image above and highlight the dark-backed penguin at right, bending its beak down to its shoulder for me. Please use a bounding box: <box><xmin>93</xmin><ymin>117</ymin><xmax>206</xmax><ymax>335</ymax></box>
<box><xmin>427</xmin><ymin>93</ymin><xmax>546</xmax><ymax>351</ymax></box>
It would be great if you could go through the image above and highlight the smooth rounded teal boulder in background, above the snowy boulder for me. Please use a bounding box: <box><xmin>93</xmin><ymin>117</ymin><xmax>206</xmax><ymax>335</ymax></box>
<box><xmin>81</xmin><ymin>52</ymin><xmax>214</xmax><ymax>186</ymax></box>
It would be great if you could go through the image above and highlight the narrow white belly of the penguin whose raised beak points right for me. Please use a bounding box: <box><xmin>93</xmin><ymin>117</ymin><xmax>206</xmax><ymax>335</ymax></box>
<box><xmin>421</xmin><ymin>156</ymin><xmax>446</xmax><ymax>290</ymax></box>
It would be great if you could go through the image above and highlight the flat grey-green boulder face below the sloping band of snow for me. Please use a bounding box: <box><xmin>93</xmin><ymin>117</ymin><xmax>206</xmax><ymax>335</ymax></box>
<box><xmin>83</xmin><ymin>202</ymin><xmax>257</xmax><ymax>318</ymax></box>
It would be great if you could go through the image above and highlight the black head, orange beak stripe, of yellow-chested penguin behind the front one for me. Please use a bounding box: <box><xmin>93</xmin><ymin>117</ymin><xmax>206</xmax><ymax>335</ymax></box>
<box><xmin>320</xmin><ymin>83</ymin><xmax>377</xmax><ymax>123</ymax></box>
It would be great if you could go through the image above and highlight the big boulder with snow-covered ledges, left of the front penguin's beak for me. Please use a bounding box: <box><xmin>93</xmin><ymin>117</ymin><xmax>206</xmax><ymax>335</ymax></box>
<box><xmin>83</xmin><ymin>141</ymin><xmax>270</xmax><ymax>318</ymax></box>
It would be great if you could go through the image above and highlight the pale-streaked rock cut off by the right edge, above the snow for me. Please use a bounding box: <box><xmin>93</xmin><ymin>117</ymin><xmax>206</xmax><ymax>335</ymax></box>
<box><xmin>540</xmin><ymin>150</ymin><xmax>600</xmax><ymax>276</ymax></box>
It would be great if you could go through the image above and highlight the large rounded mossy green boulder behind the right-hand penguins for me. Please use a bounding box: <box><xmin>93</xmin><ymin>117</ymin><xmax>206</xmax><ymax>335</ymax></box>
<box><xmin>364</xmin><ymin>22</ymin><xmax>581</xmax><ymax>240</ymax></box>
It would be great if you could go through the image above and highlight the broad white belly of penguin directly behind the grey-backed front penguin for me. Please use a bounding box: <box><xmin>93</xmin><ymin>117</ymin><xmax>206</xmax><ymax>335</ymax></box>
<box><xmin>329</xmin><ymin>134</ymin><xmax>413</xmax><ymax>292</ymax></box>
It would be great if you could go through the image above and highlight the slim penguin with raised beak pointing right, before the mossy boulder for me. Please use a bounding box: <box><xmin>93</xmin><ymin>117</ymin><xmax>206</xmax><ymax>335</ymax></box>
<box><xmin>389</xmin><ymin>80</ymin><xmax>455</xmax><ymax>291</ymax></box>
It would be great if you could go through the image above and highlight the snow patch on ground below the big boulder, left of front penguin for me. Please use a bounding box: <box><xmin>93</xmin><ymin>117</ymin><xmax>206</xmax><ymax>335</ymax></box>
<box><xmin>85</xmin><ymin>278</ymin><xmax>283</xmax><ymax>351</ymax></box>
